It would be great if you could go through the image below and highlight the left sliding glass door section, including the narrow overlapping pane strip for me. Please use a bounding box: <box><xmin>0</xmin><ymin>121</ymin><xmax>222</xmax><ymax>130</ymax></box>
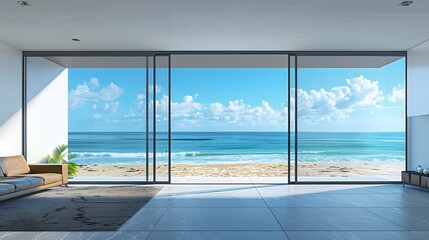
<box><xmin>26</xmin><ymin>55</ymin><xmax>170</xmax><ymax>182</ymax></box>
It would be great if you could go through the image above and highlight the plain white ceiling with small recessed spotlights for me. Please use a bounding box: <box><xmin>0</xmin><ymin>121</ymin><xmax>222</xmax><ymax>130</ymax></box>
<box><xmin>0</xmin><ymin>0</ymin><xmax>429</xmax><ymax>51</ymax></box>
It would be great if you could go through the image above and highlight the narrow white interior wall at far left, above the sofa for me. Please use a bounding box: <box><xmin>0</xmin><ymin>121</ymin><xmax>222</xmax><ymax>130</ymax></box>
<box><xmin>0</xmin><ymin>42</ymin><xmax>22</xmax><ymax>156</ymax></box>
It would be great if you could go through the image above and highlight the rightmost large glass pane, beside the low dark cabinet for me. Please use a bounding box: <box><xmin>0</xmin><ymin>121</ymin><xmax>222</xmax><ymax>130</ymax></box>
<box><xmin>297</xmin><ymin>56</ymin><xmax>405</xmax><ymax>181</ymax></box>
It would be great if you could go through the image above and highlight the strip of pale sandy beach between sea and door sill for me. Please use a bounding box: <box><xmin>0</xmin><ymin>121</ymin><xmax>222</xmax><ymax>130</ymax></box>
<box><xmin>77</xmin><ymin>162</ymin><xmax>404</xmax><ymax>177</ymax></box>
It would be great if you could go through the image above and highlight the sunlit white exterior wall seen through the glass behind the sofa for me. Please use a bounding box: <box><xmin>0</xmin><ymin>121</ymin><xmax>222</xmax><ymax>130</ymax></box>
<box><xmin>27</xmin><ymin>57</ymin><xmax>68</xmax><ymax>163</ymax></box>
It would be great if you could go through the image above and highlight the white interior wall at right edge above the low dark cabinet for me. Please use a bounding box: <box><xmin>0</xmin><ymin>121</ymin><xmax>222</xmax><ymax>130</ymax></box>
<box><xmin>407</xmin><ymin>42</ymin><xmax>429</xmax><ymax>170</ymax></box>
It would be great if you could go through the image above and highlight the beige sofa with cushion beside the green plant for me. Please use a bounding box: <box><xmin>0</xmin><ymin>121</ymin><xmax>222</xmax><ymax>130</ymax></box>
<box><xmin>0</xmin><ymin>155</ymin><xmax>68</xmax><ymax>201</ymax></box>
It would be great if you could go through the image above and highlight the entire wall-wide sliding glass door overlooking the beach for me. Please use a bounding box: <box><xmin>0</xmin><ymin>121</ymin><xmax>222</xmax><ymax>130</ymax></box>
<box><xmin>23</xmin><ymin>52</ymin><xmax>406</xmax><ymax>183</ymax></box>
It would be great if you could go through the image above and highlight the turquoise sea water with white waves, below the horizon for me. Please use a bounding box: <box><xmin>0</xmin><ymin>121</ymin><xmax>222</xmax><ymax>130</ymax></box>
<box><xmin>69</xmin><ymin>132</ymin><xmax>405</xmax><ymax>164</ymax></box>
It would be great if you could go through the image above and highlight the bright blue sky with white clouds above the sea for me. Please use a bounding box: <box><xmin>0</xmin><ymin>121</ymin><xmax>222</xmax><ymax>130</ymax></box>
<box><xmin>69</xmin><ymin>59</ymin><xmax>405</xmax><ymax>132</ymax></box>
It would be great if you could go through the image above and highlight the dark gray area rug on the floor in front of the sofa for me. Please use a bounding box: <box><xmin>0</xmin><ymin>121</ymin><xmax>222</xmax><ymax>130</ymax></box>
<box><xmin>0</xmin><ymin>186</ymin><xmax>162</xmax><ymax>231</ymax></box>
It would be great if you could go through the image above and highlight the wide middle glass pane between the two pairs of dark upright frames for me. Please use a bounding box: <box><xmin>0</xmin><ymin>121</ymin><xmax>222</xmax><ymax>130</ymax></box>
<box><xmin>172</xmin><ymin>55</ymin><xmax>288</xmax><ymax>183</ymax></box>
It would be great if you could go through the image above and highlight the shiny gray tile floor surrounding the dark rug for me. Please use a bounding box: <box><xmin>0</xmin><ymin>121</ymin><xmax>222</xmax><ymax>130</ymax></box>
<box><xmin>0</xmin><ymin>184</ymin><xmax>429</xmax><ymax>240</ymax></box>
